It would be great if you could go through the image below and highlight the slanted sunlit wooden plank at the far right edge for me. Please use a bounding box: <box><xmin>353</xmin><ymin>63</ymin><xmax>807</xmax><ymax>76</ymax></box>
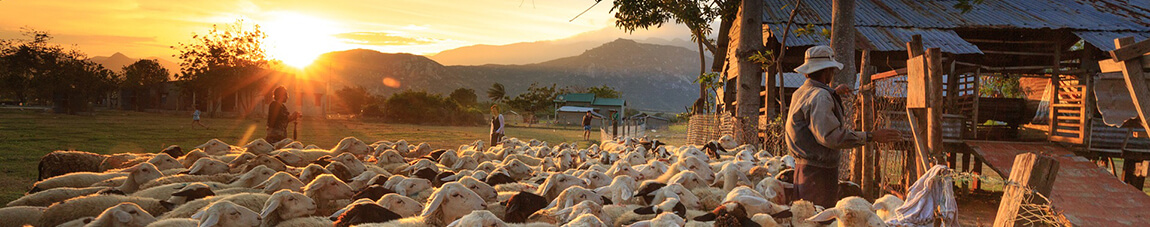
<box><xmin>1114</xmin><ymin>37</ymin><xmax>1150</xmax><ymax>138</ymax></box>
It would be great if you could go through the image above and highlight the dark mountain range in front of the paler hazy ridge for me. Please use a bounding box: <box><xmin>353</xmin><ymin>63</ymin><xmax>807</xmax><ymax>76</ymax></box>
<box><xmin>308</xmin><ymin>39</ymin><xmax>710</xmax><ymax>112</ymax></box>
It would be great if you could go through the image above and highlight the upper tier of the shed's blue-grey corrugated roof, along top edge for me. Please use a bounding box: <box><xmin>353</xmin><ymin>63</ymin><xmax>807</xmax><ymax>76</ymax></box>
<box><xmin>762</xmin><ymin>0</ymin><xmax>1150</xmax><ymax>31</ymax></box>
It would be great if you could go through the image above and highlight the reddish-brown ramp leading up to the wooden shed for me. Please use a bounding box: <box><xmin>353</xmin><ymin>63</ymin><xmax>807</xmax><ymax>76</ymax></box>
<box><xmin>966</xmin><ymin>141</ymin><xmax>1150</xmax><ymax>226</ymax></box>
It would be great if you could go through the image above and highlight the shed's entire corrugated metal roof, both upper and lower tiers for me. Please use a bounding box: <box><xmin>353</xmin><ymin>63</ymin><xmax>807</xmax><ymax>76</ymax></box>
<box><xmin>762</xmin><ymin>0</ymin><xmax>1150</xmax><ymax>54</ymax></box>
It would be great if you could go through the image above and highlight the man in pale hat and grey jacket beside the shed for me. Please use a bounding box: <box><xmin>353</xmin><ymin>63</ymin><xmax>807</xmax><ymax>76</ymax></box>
<box><xmin>785</xmin><ymin>46</ymin><xmax>902</xmax><ymax>207</ymax></box>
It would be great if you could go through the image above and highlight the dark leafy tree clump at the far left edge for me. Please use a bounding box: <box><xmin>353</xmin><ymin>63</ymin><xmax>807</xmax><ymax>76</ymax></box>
<box><xmin>0</xmin><ymin>28</ymin><xmax>120</xmax><ymax>113</ymax></box>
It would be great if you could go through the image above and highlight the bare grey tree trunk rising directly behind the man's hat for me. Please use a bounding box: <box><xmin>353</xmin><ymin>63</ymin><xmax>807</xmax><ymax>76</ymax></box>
<box><xmin>830</xmin><ymin>0</ymin><xmax>858</xmax><ymax>85</ymax></box>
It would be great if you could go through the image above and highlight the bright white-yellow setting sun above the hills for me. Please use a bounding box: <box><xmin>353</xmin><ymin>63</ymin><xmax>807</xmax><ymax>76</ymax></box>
<box><xmin>260</xmin><ymin>13</ymin><xmax>340</xmax><ymax>68</ymax></box>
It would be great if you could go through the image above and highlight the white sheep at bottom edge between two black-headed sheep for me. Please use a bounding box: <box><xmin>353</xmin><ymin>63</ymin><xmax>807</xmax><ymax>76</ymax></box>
<box><xmin>366</xmin><ymin>182</ymin><xmax>487</xmax><ymax>226</ymax></box>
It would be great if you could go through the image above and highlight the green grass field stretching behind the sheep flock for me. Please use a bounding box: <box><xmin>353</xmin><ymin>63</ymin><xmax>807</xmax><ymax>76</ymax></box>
<box><xmin>0</xmin><ymin>108</ymin><xmax>685</xmax><ymax>204</ymax></box>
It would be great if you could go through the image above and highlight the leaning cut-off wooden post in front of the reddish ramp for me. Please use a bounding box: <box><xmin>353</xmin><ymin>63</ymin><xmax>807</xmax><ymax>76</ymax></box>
<box><xmin>995</xmin><ymin>153</ymin><xmax>1058</xmax><ymax>227</ymax></box>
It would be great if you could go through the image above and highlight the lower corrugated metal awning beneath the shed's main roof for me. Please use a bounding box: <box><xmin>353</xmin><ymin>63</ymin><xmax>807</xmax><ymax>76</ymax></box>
<box><xmin>764</xmin><ymin>24</ymin><xmax>982</xmax><ymax>54</ymax></box>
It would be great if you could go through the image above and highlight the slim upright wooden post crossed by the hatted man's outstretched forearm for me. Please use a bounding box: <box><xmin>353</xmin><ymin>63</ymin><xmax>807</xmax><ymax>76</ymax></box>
<box><xmin>854</xmin><ymin>50</ymin><xmax>880</xmax><ymax>198</ymax></box>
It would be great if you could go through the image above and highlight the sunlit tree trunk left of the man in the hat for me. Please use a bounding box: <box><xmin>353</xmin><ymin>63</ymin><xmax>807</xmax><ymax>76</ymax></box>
<box><xmin>727</xmin><ymin>1</ymin><xmax>764</xmax><ymax>143</ymax></box>
